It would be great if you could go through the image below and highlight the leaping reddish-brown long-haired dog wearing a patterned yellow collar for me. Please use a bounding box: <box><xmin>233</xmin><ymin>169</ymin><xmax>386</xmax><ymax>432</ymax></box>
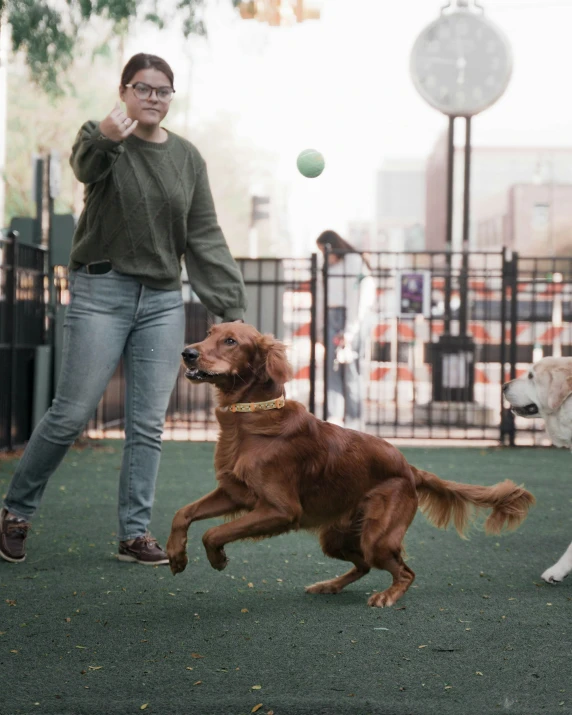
<box><xmin>167</xmin><ymin>323</ymin><xmax>534</xmax><ymax>606</ymax></box>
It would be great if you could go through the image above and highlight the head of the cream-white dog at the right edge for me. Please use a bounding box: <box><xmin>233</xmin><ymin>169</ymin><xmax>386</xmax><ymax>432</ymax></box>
<box><xmin>503</xmin><ymin>357</ymin><xmax>572</xmax><ymax>418</ymax></box>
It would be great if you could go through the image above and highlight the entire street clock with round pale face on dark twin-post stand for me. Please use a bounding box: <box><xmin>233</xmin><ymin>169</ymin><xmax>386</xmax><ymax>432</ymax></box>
<box><xmin>410</xmin><ymin>0</ymin><xmax>512</xmax><ymax>416</ymax></box>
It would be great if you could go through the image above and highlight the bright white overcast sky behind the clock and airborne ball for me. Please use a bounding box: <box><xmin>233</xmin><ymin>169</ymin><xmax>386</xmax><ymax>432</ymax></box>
<box><xmin>127</xmin><ymin>0</ymin><xmax>572</xmax><ymax>250</ymax></box>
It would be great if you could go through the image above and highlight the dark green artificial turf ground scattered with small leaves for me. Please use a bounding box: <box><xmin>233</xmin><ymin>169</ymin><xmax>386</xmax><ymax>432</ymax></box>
<box><xmin>0</xmin><ymin>441</ymin><xmax>572</xmax><ymax>715</ymax></box>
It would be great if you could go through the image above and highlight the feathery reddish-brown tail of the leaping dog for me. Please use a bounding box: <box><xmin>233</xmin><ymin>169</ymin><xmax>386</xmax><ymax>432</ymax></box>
<box><xmin>411</xmin><ymin>466</ymin><xmax>535</xmax><ymax>538</ymax></box>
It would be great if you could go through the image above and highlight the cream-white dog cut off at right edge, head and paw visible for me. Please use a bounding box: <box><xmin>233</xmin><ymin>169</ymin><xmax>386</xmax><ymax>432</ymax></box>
<box><xmin>503</xmin><ymin>357</ymin><xmax>572</xmax><ymax>583</ymax></box>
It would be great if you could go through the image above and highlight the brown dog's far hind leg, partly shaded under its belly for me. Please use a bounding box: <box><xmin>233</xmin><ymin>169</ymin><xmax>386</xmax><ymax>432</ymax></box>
<box><xmin>306</xmin><ymin>524</ymin><xmax>370</xmax><ymax>593</ymax></box>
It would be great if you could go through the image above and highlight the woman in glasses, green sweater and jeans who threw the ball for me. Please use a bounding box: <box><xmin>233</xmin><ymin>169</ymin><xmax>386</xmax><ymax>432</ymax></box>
<box><xmin>0</xmin><ymin>54</ymin><xmax>246</xmax><ymax>565</ymax></box>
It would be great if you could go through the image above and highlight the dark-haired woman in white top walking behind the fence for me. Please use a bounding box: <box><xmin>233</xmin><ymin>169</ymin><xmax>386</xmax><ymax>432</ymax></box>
<box><xmin>316</xmin><ymin>230</ymin><xmax>375</xmax><ymax>430</ymax></box>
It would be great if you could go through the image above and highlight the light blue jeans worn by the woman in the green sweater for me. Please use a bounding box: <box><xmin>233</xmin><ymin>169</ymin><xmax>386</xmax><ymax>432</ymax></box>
<box><xmin>4</xmin><ymin>270</ymin><xmax>185</xmax><ymax>541</ymax></box>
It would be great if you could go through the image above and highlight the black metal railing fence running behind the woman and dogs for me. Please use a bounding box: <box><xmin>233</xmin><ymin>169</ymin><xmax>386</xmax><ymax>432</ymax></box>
<box><xmin>0</xmin><ymin>240</ymin><xmax>572</xmax><ymax>449</ymax></box>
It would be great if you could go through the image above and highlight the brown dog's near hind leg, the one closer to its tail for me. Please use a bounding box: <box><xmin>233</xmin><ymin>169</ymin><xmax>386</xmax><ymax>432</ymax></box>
<box><xmin>361</xmin><ymin>480</ymin><xmax>417</xmax><ymax>608</ymax></box>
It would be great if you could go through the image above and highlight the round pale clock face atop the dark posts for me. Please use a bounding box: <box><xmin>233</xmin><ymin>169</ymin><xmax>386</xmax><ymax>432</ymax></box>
<box><xmin>410</xmin><ymin>10</ymin><xmax>512</xmax><ymax>117</ymax></box>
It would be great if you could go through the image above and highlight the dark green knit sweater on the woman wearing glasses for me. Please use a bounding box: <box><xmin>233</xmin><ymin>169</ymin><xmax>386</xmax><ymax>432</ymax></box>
<box><xmin>70</xmin><ymin>121</ymin><xmax>246</xmax><ymax>320</ymax></box>
